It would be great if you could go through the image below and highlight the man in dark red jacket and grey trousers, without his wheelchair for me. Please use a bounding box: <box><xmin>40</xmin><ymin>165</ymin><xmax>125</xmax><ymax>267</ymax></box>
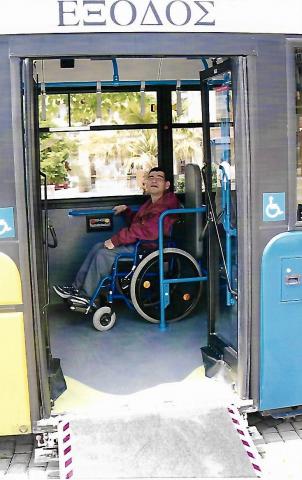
<box><xmin>53</xmin><ymin>167</ymin><xmax>180</xmax><ymax>302</ymax></box>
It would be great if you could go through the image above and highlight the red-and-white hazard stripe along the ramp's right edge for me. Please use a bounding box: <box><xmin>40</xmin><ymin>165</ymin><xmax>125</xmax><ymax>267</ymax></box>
<box><xmin>228</xmin><ymin>404</ymin><xmax>262</xmax><ymax>477</ymax></box>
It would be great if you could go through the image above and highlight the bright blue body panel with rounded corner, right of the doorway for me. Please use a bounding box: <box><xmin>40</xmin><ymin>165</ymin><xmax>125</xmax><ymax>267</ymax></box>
<box><xmin>260</xmin><ymin>232</ymin><xmax>302</xmax><ymax>410</ymax></box>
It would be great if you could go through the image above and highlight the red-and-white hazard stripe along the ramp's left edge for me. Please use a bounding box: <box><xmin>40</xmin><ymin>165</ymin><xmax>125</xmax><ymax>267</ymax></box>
<box><xmin>58</xmin><ymin>417</ymin><xmax>73</xmax><ymax>480</ymax></box>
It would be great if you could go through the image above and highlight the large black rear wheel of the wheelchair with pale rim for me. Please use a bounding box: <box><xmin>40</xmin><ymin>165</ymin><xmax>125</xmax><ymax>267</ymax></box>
<box><xmin>130</xmin><ymin>248</ymin><xmax>202</xmax><ymax>323</ymax></box>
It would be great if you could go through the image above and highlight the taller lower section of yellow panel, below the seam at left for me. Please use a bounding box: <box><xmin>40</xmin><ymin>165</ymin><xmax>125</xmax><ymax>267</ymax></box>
<box><xmin>0</xmin><ymin>312</ymin><xmax>31</xmax><ymax>435</ymax></box>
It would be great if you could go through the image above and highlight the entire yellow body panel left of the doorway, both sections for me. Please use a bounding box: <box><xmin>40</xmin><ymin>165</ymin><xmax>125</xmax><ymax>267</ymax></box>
<box><xmin>0</xmin><ymin>253</ymin><xmax>31</xmax><ymax>435</ymax></box>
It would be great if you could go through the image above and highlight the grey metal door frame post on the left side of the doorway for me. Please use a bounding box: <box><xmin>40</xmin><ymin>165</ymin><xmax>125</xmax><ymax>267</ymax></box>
<box><xmin>11</xmin><ymin>58</ymin><xmax>51</xmax><ymax>421</ymax></box>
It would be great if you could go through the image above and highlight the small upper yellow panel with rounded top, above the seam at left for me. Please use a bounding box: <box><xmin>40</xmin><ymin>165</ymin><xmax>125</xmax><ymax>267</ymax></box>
<box><xmin>0</xmin><ymin>252</ymin><xmax>22</xmax><ymax>305</ymax></box>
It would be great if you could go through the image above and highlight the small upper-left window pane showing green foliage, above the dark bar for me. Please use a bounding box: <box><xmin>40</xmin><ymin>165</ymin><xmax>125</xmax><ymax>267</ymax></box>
<box><xmin>39</xmin><ymin>94</ymin><xmax>68</xmax><ymax>128</ymax></box>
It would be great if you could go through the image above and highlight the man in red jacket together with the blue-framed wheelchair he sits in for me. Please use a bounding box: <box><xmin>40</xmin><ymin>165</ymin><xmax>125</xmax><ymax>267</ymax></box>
<box><xmin>53</xmin><ymin>164</ymin><xmax>207</xmax><ymax>331</ymax></box>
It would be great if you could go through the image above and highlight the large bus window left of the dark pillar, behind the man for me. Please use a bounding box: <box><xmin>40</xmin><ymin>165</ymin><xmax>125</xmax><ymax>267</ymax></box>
<box><xmin>40</xmin><ymin>92</ymin><xmax>158</xmax><ymax>199</ymax></box>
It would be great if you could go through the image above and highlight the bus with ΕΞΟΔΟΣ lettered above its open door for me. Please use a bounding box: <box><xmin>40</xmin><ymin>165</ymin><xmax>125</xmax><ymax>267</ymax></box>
<box><xmin>0</xmin><ymin>0</ymin><xmax>302</xmax><ymax>476</ymax></box>
